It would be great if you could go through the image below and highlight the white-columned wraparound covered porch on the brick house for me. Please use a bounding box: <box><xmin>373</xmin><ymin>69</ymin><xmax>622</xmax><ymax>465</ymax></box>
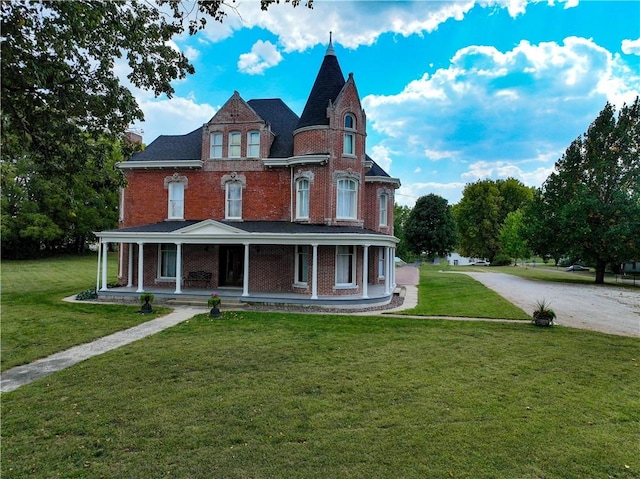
<box><xmin>96</xmin><ymin>220</ymin><xmax>397</xmax><ymax>306</ymax></box>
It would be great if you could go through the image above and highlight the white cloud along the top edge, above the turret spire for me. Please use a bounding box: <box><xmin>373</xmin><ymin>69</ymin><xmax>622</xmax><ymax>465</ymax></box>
<box><xmin>195</xmin><ymin>0</ymin><xmax>564</xmax><ymax>53</ymax></box>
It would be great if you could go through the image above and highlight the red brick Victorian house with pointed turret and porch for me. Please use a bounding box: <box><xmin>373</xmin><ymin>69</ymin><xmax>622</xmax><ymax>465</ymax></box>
<box><xmin>96</xmin><ymin>39</ymin><xmax>400</xmax><ymax>304</ymax></box>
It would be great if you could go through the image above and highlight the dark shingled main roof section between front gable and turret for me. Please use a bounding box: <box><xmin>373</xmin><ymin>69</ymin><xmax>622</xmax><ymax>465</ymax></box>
<box><xmin>247</xmin><ymin>98</ymin><xmax>299</xmax><ymax>158</ymax></box>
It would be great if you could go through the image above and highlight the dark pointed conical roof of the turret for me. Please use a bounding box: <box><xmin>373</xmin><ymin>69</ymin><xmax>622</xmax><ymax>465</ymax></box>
<box><xmin>298</xmin><ymin>51</ymin><xmax>346</xmax><ymax>128</ymax></box>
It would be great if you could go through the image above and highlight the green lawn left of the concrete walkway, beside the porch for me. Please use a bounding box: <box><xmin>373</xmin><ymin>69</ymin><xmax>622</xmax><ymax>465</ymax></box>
<box><xmin>0</xmin><ymin>255</ymin><xmax>168</xmax><ymax>371</ymax></box>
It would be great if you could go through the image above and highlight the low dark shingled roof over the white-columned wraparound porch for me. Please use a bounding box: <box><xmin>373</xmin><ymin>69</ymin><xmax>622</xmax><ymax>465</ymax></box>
<box><xmin>109</xmin><ymin>220</ymin><xmax>383</xmax><ymax>235</ymax></box>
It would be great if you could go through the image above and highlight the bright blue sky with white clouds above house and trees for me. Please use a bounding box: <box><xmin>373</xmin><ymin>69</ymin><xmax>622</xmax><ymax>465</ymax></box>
<box><xmin>126</xmin><ymin>0</ymin><xmax>640</xmax><ymax>206</ymax></box>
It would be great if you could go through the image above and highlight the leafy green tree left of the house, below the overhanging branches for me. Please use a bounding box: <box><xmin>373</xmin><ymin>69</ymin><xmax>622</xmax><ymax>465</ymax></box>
<box><xmin>1</xmin><ymin>135</ymin><xmax>128</xmax><ymax>258</ymax></box>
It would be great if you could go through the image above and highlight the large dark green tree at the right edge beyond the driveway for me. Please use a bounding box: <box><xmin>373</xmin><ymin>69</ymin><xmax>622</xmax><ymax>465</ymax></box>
<box><xmin>541</xmin><ymin>98</ymin><xmax>640</xmax><ymax>284</ymax></box>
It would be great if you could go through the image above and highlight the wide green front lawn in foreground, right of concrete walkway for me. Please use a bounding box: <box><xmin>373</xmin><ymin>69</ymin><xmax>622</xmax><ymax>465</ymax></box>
<box><xmin>0</xmin><ymin>260</ymin><xmax>640</xmax><ymax>479</ymax></box>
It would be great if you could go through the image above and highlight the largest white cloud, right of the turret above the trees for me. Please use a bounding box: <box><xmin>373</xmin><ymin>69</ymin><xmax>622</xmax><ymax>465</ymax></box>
<box><xmin>363</xmin><ymin>37</ymin><xmax>640</xmax><ymax>201</ymax></box>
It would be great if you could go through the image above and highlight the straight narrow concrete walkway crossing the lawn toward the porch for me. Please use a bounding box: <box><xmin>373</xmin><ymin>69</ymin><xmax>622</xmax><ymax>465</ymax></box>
<box><xmin>0</xmin><ymin>307</ymin><xmax>206</xmax><ymax>393</ymax></box>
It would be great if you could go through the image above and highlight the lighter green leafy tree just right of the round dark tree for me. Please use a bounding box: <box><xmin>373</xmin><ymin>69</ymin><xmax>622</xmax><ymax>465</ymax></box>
<box><xmin>453</xmin><ymin>178</ymin><xmax>533</xmax><ymax>261</ymax></box>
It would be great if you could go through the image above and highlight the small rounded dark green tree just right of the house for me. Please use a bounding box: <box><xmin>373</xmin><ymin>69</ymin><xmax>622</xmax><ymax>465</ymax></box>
<box><xmin>405</xmin><ymin>194</ymin><xmax>456</xmax><ymax>258</ymax></box>
